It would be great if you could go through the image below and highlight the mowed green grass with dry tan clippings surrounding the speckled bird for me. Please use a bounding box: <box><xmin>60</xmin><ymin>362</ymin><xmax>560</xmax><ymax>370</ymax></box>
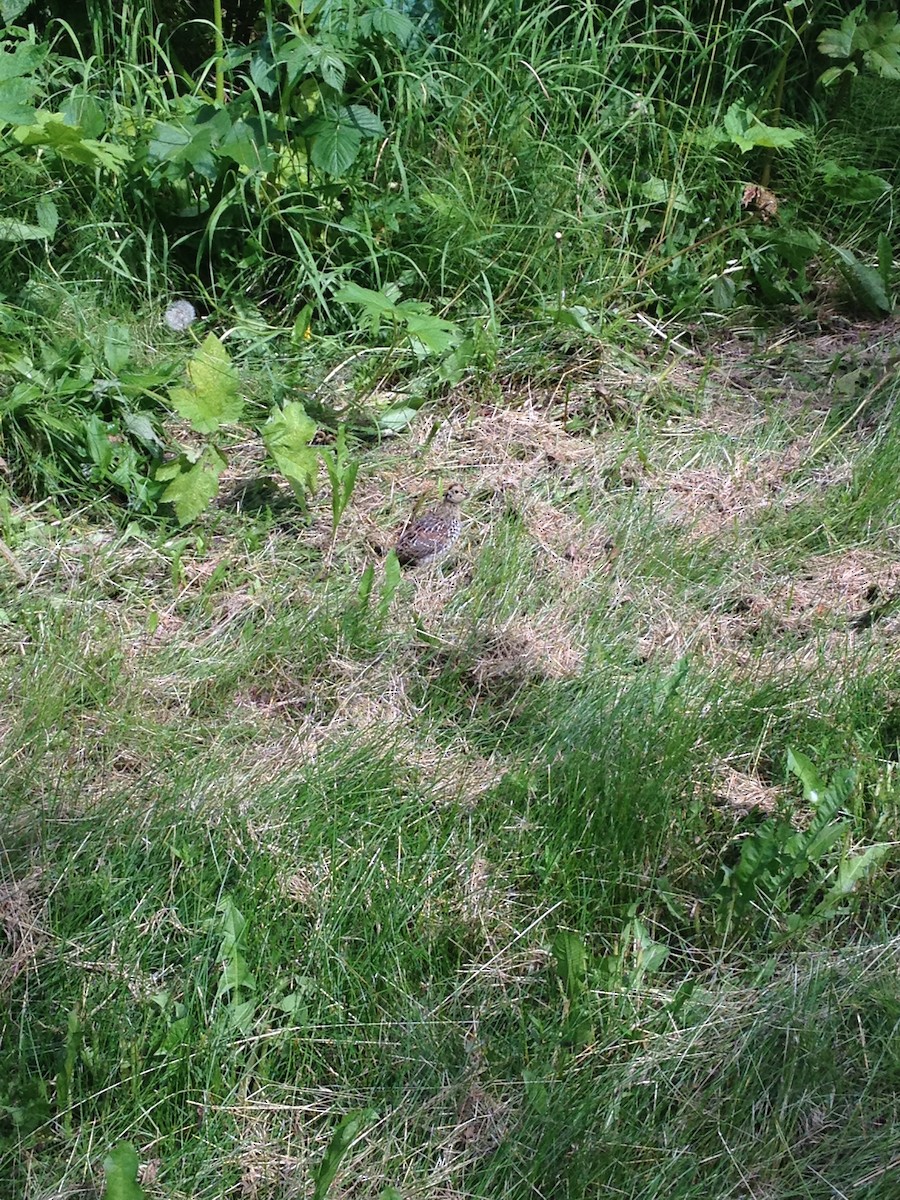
<box><xmin>0</xmin><ymin>324</ymin><xmax>900</xmax><ymax>1200</ymax></box>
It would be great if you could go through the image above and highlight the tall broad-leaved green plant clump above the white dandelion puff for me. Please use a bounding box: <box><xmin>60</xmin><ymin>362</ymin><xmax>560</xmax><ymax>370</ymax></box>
<box><xmin>136</xmin><ymin>0</ymin><xmax>415</xmax><ymax>276</ymax></box>
